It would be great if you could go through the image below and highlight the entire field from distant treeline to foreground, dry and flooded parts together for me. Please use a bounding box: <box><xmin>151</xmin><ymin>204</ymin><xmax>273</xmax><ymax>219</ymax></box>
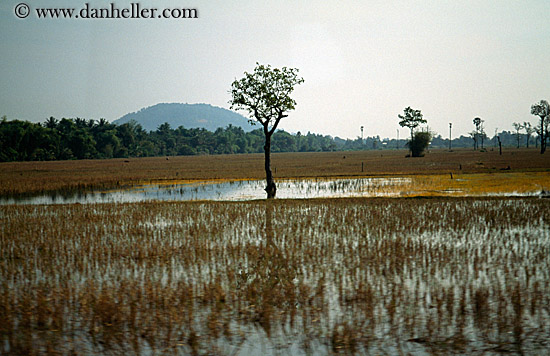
<box><xmin>0</xmin><ymin>150</ymin><xmax>550</xmax><ymax>356</ymax></box>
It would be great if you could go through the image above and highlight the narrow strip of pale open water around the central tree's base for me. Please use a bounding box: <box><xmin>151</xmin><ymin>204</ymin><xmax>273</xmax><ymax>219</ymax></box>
<box><xmin>0</xmin><ymin>178</ymin><xmax>411</xmax><ymax>205</ymax></box>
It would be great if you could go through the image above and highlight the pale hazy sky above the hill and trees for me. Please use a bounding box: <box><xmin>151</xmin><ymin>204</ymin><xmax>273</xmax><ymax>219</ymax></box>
<box><xmin>0</xmin><ymin>0</ymin><xmax>550</xmax><ymax>138</ymax></box>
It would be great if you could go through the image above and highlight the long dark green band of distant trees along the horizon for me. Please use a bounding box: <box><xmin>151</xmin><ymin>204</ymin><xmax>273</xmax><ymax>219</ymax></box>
<box><xmin>0</xmin><ymin>117</ymin><xmax>537</xmax><ymax>162</ymax></box>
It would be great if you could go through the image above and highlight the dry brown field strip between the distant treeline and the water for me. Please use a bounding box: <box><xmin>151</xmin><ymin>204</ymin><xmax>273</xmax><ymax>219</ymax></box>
<box><xmin>0</xmin><ymin>149</ymin><xmax>550</xmax><ymax>196</ymax></box>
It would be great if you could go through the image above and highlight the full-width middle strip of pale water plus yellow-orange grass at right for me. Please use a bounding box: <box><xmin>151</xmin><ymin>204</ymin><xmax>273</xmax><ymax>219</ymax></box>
<box><xmin>0</xmin><ymin>173</ymin><xmax>550</xmax><ymax>205</ymax></box>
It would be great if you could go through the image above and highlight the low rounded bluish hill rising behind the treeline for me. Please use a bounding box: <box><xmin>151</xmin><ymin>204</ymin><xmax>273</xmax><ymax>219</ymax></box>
<box><xmin>113</xmin><ymin>103</ymin><xmax>255</xmax><ymax>131</ymax></box>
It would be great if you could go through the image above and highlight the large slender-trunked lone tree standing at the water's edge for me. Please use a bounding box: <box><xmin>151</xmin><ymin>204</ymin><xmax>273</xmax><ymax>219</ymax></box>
<box><xmin>229</xmin><ymin>63</ymin><xmax>304</xmax><ymax>199</ymax></box>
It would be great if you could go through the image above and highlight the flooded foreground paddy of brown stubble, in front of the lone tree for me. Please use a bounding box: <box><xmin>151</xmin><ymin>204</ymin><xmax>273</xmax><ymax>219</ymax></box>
<box><xmin>0</xmin><ymin>197</ymin><xmax>550</xmax><ymax>355</ymax></box>
